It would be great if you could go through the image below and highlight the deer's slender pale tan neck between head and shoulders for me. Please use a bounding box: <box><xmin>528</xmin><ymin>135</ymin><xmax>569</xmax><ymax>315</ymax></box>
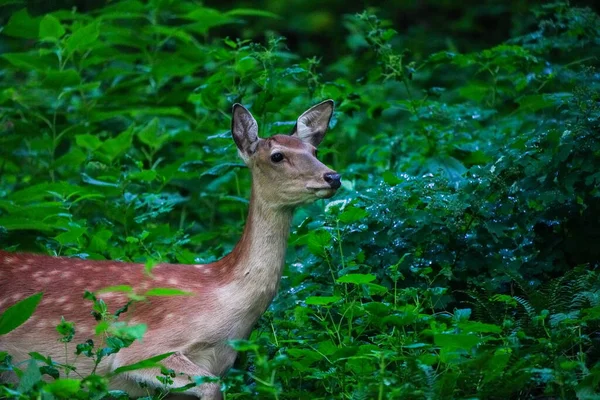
<box><xmin>225</xmin><ymin>185</ymin><xmax>293</xmax><ymax>296</ymax></box>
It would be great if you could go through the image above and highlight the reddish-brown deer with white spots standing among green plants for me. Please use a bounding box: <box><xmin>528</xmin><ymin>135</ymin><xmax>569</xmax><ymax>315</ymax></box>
<box><xmin>0</xmin><ymin>100</ymin><xmax>340</xmax><ymax>399</ymax></box>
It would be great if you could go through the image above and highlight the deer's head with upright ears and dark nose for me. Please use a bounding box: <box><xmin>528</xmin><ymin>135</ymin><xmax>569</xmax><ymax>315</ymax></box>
<box><xmin>231</xmin><ymin>100</ymin><xmax>341</xmax><ymax>208</ymax></box>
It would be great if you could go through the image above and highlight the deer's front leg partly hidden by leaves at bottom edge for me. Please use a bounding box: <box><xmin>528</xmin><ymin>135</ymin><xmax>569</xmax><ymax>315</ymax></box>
<box><xmin>113</xmin><ymin>352</ymin><xmax>223</xmax><ymax>400</ymax></box>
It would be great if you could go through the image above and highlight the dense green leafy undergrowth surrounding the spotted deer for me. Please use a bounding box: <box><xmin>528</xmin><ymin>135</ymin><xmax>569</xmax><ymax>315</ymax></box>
<box><xmin>0</xmin><ymin>0</ymin><xmax>600</xmax><ymax>399</ymax></box>
